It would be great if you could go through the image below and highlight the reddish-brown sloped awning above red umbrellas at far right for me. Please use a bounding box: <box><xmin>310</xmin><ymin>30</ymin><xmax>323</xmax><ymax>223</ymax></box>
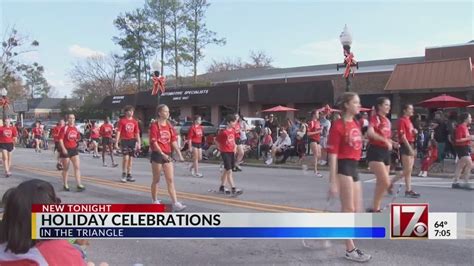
<box><xmin>385</xmin><ymin>57</ymin><xmax>474</xmax><ymax>91</ymax></box>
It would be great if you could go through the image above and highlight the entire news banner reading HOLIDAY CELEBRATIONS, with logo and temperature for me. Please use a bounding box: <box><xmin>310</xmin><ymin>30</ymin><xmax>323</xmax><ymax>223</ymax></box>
<box><xmin>31</xmin><ymin>204</ymin><xmax>472</xmax><ymax>239</ymax></box>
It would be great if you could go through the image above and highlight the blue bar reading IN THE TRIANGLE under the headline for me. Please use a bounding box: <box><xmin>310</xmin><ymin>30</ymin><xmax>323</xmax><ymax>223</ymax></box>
<box><xmin>40</xmin><ymin>227</ymin><xmax>385</xmax><ymax>239</ymax></box>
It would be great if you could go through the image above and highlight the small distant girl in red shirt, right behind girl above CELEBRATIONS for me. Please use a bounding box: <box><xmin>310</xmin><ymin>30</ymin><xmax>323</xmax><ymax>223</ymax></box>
<box><xmin>188</xmin><ymin>115</ymin><xmax>204</xmax><ymax>177</ymax></box>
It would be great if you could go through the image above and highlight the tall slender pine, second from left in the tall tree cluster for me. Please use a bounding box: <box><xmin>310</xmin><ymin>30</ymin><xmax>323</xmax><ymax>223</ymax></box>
<box><xmin>145</xmin><ymin>0</ymin><xmax>171</xmax><ymax>75</ymax></box>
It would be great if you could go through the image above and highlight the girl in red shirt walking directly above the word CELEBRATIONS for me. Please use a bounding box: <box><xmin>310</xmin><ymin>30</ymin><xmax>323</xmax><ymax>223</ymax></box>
<box><xmin>149</xmin><ymin>104</ymin><xmax>186</xmax><ymax>211</ymax></box>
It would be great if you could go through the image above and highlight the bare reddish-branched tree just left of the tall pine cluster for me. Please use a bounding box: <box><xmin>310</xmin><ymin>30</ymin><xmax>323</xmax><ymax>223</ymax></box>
<box><xmin>69</xmin><ymin>54</ymin><xmax>131</xmax><ymax>101</ymax></box>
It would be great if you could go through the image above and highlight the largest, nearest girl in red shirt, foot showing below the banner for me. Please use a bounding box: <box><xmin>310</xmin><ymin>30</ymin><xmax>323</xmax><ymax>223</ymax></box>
<box><xmin>328</xmin><ymin>92</ymin><xmax>372</xmax><ymax>262</ymax></box>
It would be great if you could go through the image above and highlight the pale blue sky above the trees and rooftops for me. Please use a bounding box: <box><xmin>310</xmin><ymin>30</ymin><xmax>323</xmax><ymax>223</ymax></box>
<box><xmin>0</xmin><ymin>0</ymin><xmax>474</xmax><ymax>97</ymax></box>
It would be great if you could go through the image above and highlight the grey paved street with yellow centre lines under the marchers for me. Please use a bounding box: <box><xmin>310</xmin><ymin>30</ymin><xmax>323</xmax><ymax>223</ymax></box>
<box><xmin>0</xmin><ymin>149</ymin><xmax>474</xmax><ymax>265</ymax></box>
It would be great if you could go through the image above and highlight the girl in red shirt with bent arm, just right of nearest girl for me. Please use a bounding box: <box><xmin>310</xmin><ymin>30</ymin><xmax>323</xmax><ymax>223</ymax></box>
<box><xmin>367</xmin><ymin>97</ymin><xmax>393</xmax><ymax>212</ymax></box>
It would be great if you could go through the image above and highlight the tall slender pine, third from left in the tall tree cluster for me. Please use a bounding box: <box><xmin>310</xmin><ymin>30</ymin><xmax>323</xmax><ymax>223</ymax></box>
<box><xmin>168</xmin><ymin>0</ymin><xmax>191</xmax><ymax>86</ymax></box>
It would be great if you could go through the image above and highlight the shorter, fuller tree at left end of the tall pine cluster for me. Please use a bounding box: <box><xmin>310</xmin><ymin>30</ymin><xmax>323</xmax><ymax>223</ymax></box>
<box><xmin>113</xmin><ymin>9</ymin><xmax>153</xmax><ymax>90</ymax></box>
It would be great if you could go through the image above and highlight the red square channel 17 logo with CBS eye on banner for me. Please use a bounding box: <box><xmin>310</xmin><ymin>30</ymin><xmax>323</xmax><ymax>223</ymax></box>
<box><xmin>390</xmin><ymin>204</ymin><xmax>428</xmax><ymax>239</ymax></box>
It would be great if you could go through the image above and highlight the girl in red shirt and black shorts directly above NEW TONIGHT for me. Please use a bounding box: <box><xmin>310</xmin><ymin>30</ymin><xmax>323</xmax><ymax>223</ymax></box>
<box><xmin>59</xmin><ymin>114</ymin><xmax>86</xmax><ymax>192</ymax></box>
